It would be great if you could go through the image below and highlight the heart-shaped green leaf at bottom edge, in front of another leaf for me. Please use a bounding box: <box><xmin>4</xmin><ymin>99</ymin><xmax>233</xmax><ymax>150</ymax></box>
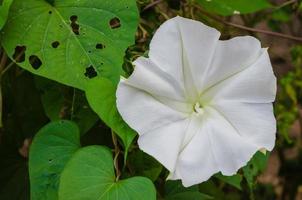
<box><xmin>59</xmin><ymin>146</ymin><xmax>156</xmax><ymax>200</ymax></box>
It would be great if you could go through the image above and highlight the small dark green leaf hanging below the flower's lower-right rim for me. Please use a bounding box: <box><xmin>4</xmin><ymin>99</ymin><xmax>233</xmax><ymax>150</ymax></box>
<box><xmin>243</xmin><ymin>151</ymin><xmax>269</xmax><ymax>189</ymax></box>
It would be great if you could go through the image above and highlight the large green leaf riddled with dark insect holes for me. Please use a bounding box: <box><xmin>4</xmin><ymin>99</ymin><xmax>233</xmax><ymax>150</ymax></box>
<box><xmin>2</xmin><ymin>0</ymin><xmax>138</xmax><ymax>90</ymax></box>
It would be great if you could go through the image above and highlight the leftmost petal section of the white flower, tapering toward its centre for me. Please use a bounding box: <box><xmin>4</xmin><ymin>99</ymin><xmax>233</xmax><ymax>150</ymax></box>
<box><xmin>116</xmin><ymin>80</ymin><xmax>187</xmax><ymax>135</ymax></box>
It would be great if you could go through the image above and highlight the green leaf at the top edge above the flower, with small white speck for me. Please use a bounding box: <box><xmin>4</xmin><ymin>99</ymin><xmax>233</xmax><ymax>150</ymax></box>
<box><xmin>196</xmin><ymin>0</ymin><xmax>272</xmax><ymax>16</ymax></box>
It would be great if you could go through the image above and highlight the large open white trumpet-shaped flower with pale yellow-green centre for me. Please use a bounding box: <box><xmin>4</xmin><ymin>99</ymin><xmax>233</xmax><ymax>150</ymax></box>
<box><xmin>117</xmin><ymin>17</ymin><xmax>276</xmax><ymax>186</ymax></box>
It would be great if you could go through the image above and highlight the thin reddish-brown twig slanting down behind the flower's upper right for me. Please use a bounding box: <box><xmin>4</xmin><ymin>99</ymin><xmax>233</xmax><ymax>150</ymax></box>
<box><xmin>194</xmin><ymin>5</ymin><xmax>302</xmax><ymax>42</ymax></box>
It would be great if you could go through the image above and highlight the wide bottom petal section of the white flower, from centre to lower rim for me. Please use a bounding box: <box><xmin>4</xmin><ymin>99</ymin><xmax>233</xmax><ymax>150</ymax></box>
<box><xmin>172</xmin><ymin>107</ymin><xmax>260</xmax><ymax>187</ymax></box>
